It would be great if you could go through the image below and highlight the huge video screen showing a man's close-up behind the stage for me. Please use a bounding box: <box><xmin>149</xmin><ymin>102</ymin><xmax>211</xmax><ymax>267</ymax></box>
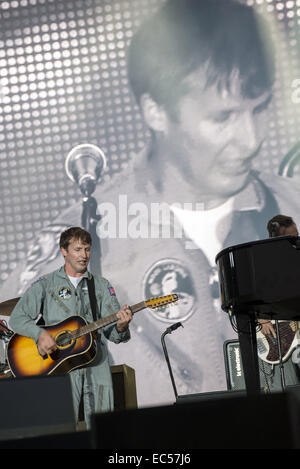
<box><xmin>0</xmin><ymin>0</ymin><xmax>300</xmax><ymax>406</ymax></box>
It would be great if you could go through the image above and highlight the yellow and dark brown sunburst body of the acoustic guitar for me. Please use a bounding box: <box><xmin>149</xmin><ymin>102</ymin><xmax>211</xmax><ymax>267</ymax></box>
<box><xmin>7</xmin><ymin>316</ymin><xmax>97</xmax><ymax>377</ymax></box>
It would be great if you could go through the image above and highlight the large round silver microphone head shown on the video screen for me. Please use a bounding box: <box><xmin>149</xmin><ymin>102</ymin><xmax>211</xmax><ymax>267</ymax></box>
<box><xmin>65</xmin><ymin>143</ymin><xmax>106</xmax><ymax>197</ymax></box>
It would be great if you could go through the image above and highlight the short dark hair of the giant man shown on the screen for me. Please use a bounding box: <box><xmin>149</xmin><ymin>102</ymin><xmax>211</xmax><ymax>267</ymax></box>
<box><xmin>128</xmin><ymin>0</ymin><xmax>274</xmax><ymax>116</ymax></box>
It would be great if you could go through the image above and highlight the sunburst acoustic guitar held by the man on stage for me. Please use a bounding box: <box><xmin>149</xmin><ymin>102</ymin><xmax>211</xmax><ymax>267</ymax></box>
<box><xmin>6</xmin><ymin>294</ymin><xmax>178</xmax><ymax>377</ymax></box>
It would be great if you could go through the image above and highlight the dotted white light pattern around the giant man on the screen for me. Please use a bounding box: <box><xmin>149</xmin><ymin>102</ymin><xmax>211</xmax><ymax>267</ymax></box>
<box><xmin>0</xmin><ymin>0</ymin><xmax>300</xmax><ymax>282</ymax></box>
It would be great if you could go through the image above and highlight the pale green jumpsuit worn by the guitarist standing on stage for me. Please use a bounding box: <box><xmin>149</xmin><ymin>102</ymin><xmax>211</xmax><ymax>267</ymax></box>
<box><xmin>9</xmin><ymin>267</ymin><xmax>130</xmax><ymax>428</ymax></box>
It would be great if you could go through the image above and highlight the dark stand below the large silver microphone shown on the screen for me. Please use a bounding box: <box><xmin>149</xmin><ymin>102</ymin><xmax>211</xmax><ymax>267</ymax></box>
<box><xmin>81</xmin><ymin>194</ymin><xmax>101</xmax><ymax>275</ymax></box>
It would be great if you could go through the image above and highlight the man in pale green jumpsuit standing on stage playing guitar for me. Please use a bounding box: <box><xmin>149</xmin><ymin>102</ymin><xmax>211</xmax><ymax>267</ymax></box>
<box><xmin>10</xmin><ymin>227</ymin><xmax>132</xmax><ymax>428</ymax></box>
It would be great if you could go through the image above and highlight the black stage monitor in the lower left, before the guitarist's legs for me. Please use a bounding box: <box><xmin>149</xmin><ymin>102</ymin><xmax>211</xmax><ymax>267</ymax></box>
<box><xmin>0</xmin><ymin>375</ymin><xmax>76</xmax><ymax>440</ymax></box>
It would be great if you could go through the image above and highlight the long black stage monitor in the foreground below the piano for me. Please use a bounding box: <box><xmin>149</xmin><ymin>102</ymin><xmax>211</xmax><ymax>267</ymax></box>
<box><xmin>92</xmin><ymin>392</ymin><xmax>300</xmax><ymax>448</ymax></box>
